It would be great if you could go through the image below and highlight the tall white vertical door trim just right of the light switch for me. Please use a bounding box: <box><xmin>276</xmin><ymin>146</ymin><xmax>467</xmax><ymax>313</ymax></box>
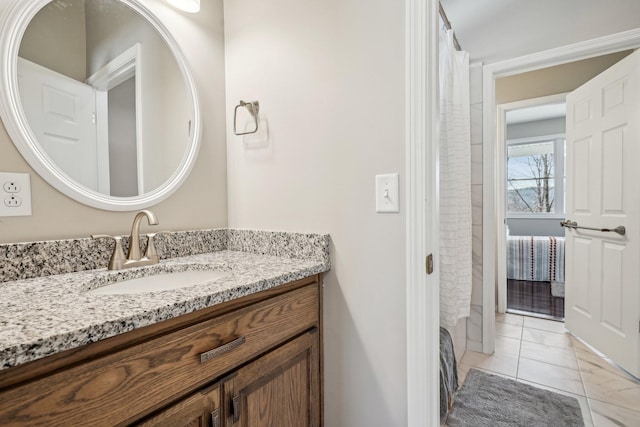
<box><xmin>405</xmin><ymin>0</ymin><xmax>440</xmax><ymax>427</ymax></box>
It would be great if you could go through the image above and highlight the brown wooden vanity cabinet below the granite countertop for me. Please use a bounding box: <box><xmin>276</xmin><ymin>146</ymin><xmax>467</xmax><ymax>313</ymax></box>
<box><xmin>0</xmin><ymin>275</ymin><xmax>322</xmax><ymax>427</ymax></box>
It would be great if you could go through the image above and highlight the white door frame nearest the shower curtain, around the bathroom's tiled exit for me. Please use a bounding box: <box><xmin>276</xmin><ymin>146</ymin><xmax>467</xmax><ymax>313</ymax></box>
<box><xmin>482</xmin><ymin>28</ymin><xmax>640</xmax><ymax>354</ymax></box>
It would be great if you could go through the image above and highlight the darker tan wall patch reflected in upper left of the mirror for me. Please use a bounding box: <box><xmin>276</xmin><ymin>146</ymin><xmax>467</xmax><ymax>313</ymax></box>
<box><xmin>19</xmin><ymin>0</ymin><xmax>87</xmax><ymax>82</ymax></box>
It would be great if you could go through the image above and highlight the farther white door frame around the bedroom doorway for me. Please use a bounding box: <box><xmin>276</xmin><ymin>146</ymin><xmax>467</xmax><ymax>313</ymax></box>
<box><xmin>495</xmin><ymin>93</ymin><xmax>567</xmax><ymax>313</ymax></box>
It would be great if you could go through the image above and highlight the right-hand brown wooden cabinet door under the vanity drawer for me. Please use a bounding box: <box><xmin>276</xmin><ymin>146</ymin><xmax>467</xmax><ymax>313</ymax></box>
<box><xmin>222</xmin><ymin>329</ymin><xmax>320</xmax><ymax>427</ymax></box>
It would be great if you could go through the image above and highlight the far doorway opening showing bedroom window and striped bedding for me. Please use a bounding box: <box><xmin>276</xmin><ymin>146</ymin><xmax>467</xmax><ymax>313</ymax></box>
<box><xmin>498</xmin><ymin>98</ymin><xmax>566</xmax><ymax>321</ymax></box>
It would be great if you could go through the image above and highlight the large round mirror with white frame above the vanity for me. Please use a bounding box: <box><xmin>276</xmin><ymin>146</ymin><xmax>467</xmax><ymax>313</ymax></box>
<box><xmin>0</xmin><ymin>0</ymin><xmax>201</xmax><ymax>211</ymax></box>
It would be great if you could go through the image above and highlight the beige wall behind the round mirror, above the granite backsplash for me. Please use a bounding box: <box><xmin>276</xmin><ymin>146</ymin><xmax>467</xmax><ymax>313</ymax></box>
<box><xmin>0</xmin><ymin>0</ymin><xmax>227</xmax><ymax>242</ymax></box>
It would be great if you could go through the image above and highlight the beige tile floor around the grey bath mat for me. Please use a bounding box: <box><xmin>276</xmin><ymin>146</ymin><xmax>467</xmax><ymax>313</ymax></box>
<box><xmin>459</xmin><ymin>314</ymin><xmax>640</xmax><ymax>427</ymax></box>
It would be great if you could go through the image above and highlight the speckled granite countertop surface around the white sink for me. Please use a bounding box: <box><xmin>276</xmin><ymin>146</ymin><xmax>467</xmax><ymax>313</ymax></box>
<box><xmin>0</xmin><ymin>250</ymin><xmax>329</xmax><ymax>370</ymax></box>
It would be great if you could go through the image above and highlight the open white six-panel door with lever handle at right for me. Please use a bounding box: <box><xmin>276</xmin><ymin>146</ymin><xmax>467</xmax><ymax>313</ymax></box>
<box><xmin>565</xmin><ymin>51</ymin><xmax>640</xmax><ymax>376</ymax></box>
